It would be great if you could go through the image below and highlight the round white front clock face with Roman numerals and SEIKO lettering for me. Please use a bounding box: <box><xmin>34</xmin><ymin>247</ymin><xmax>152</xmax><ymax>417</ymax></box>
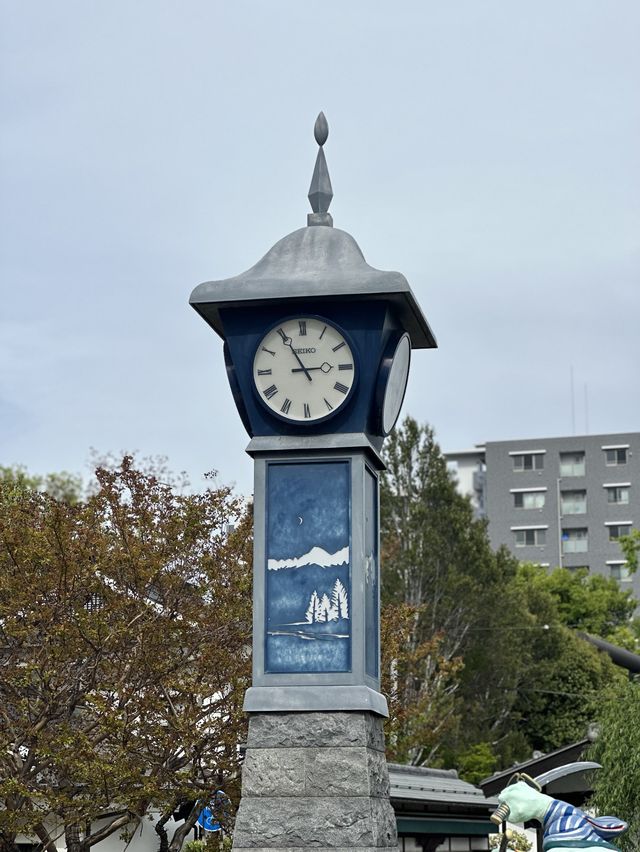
<box><xmin>253</xmin><ymin>317</ymin><xmax>356</xmax><ymax>423</ymax></box>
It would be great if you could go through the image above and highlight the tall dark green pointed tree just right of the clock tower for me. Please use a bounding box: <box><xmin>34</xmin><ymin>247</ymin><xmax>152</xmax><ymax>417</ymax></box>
<box><xmin>381</xmin><ymin>417</ymin><xmax>531</xmax><ymax>763</ymax></box>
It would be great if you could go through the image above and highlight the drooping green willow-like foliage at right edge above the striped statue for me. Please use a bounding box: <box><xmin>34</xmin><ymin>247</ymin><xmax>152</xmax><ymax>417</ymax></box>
<box><xmin>588</xmin><ymin>681</ymin><xmax>640</xmax><ymax>852</ymax></box>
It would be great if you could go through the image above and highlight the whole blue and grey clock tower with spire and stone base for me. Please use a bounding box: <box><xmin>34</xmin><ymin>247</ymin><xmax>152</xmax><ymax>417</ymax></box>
<box><xmin>190</xmin><ymin>113</ymin><xmax>436</xmax><ymax>852</ymax></box>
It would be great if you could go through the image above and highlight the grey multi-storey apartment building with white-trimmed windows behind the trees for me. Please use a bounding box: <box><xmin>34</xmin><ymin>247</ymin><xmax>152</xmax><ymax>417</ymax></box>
<box><xmin>445</xmin><ymin>432</ymin><xmax>640</xmax><ymax>597</ymax></box>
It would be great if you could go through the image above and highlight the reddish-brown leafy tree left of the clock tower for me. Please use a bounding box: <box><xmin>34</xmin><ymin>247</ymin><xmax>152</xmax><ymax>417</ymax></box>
<box><xmin>0</xmin><ymin>457</ymin><xmax>251</xmax><ymax>852</ymax></box>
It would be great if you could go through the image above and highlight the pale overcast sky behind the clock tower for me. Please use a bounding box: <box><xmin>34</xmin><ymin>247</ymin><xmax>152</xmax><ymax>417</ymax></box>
<box><xmin>0</xmin><ymin>0</ymin><xmax>640</xmax><ymax>493</ymax></box>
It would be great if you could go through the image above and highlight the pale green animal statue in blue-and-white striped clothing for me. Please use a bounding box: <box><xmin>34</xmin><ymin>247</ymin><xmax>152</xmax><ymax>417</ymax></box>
<box><xmin>491</xmin><ymin>772</ymin><xmax>627</xmax><ymax>852</ymax></box>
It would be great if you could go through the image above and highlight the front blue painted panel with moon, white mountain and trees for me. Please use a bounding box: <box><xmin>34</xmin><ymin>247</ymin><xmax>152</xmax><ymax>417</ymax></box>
<box><xmin>265</xmin><ymin>461</ymin><xmax>351</xmax><ymax>673</ymax></box>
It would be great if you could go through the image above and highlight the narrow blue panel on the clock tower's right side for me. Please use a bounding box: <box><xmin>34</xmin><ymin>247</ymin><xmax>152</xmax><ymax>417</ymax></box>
<box><xmin>364</xmin><ymin>468</ymin><xmax>380</xmax><ymax>678</ymax></box>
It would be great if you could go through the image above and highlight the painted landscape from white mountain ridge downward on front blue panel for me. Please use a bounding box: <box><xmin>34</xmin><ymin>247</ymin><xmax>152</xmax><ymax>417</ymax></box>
<box><xmin>265</xmin><ymin>545</ymin><xmax>351</xmax><ymax>672</ymax></box>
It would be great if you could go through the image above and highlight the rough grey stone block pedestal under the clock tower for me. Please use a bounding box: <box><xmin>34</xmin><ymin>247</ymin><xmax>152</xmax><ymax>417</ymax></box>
<box><xmin>233</xmin><ymin>711</ymin><xmax>397</xmax><ymax>852</ymax></box>
